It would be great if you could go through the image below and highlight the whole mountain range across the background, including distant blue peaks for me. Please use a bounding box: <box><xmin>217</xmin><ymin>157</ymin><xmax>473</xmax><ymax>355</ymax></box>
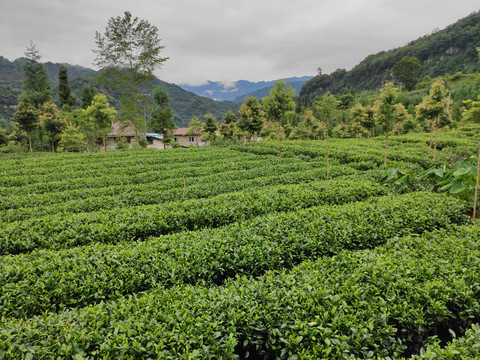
<box><xmin>0</xmin><ymin>11</ymin><xmax>480</xmax><ymax>127</ymax></box>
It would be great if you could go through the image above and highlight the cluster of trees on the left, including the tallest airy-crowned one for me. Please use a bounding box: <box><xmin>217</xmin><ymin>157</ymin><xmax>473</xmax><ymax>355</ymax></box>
<box><xmin>0</xmin><ymin>12</ymin><xmax>175</xmax><ymax>152</ymax></box>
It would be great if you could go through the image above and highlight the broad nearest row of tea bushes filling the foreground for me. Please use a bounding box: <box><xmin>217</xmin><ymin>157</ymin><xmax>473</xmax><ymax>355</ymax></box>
<box><xmin>0</xmin><ymin>225</ymin><xmax>480</xmax><ymax>359</ymax></box>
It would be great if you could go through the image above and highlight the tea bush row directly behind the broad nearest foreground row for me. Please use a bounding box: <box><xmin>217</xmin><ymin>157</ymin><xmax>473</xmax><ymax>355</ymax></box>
<box><xmin>0</xmin><ymin>193</ymin><xmax>468</xmax><ymax>317</ymax></box>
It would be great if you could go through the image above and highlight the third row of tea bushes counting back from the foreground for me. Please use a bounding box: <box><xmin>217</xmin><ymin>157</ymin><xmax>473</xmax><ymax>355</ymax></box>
<box><xmin>0</xmin><ymin>173</ymin><xmax>366</xmax><ymax>255</ymax></box>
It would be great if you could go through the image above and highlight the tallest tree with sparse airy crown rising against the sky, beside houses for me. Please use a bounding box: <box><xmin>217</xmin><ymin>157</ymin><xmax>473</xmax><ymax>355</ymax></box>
<box><xmin>94</xmin><ymin>11</ymin><xmax>168</xmax><ymax>137</ymax></box>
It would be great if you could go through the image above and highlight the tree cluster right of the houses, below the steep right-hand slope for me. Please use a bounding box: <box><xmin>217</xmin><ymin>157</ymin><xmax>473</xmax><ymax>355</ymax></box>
<box><xmin>191</xmin><ymin>47</ymin><xmax>480</xmax><ymax>166</ymax></box>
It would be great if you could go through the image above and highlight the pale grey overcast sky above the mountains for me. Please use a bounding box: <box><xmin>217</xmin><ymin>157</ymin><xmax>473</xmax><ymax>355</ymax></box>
<box><xmin>0</xmin><ymin>0</ymin><xmax>480</xmax><ymax>84</ymax></box>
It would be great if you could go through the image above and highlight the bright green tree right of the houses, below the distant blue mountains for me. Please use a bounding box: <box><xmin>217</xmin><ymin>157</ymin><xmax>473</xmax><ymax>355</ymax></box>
<box><xmin>262</xmin><ymin>80</ymin><xmax>295</xmax><ymax>157</ymax></box>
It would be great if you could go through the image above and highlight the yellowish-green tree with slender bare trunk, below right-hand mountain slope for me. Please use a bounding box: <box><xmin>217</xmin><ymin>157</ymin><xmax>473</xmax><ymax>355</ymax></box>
<box><xmin>415</xmin><ymin>79</ymin><xmax>451</xmax><ymax>160</ymax></box>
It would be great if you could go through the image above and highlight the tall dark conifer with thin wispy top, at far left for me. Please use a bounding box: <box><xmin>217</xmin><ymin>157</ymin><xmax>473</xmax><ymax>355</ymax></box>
<box><xmin>21</xmin><ymin>43</ymin><xmax>51</xmax><ymax>109</ymax></box>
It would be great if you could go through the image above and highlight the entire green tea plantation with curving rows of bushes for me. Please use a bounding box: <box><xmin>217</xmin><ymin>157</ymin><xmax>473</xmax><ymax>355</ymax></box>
<box><xmin>0</xmin><ymin>128</ymin><xmax>480</xmax><ymax>359</ymax></box>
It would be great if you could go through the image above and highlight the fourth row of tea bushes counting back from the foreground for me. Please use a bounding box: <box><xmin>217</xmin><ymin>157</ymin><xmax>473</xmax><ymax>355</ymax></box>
<box><xmin>0</xmin><ymin>162</ymin><xmax>348</xmax><ymax>215</ymax></box>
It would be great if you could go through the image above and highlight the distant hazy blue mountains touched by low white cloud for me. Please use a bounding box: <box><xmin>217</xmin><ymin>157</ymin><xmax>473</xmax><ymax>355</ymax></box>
<box><xmin>180</xmin><ymin>76</ymin><xmax>312</xmax><ymax>104</ymax></box>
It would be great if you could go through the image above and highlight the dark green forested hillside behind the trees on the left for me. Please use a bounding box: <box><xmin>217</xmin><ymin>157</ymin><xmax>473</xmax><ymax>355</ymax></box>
<box><xmin>0</xmin><ymin>56</ymin><xmax>239</xmax><ymax>127</ymax></box>
